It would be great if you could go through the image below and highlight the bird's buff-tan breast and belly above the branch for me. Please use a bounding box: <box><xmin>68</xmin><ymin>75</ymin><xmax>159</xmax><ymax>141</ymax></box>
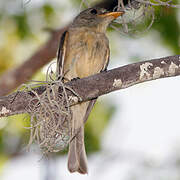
<box><xmin>64</xmin><ymin>30</ymin><xmax>109</xmax><ymax>79</ymax></box>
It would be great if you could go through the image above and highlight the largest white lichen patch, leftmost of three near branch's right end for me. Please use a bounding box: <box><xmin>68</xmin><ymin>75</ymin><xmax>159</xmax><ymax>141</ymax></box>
<box><xmin>139</xmin><ymin>62</ymin><xmax>153</xmax><ymax>80</ymax></box>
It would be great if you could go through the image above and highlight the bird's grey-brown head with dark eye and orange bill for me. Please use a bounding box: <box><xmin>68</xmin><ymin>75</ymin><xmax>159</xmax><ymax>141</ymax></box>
<box><xmin>72</xmin><ymin>7</ymin><xmax>124</xmax><ymax>32</ymax></box>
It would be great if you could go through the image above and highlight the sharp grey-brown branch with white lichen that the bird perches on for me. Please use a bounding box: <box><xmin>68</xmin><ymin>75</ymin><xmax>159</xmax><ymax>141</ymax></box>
<box><xmin>0</xmin><ymin>55</ymin><xmax>180</xmax><ymax>117</ymax></box>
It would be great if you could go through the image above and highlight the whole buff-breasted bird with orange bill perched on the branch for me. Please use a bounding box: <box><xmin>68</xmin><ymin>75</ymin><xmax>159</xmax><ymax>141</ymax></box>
<box><xmin>56</xmin><ymin>7</ymin><xmax>124</xmax><ymax>174</ymax></box>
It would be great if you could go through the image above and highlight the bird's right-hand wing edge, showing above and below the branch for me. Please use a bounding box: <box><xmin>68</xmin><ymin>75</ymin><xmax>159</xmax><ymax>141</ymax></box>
<box><xmin>84</xmin><ymin>48</ymin><xmax>110</xmax><ymax>123</ymax></box>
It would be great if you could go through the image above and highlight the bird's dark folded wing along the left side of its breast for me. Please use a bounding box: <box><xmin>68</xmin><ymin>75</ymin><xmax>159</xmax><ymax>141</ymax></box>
<box><xmin>56</xmin><ymin>31</ymin><xmax>69</xmax><ymax>80</ymax></box>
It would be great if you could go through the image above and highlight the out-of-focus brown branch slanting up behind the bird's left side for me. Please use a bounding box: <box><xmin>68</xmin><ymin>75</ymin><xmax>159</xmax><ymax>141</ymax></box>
<box><xmin>0</xmin><ymin>27</ymin><xmax>67</xmax><ymax>96</ymax></box>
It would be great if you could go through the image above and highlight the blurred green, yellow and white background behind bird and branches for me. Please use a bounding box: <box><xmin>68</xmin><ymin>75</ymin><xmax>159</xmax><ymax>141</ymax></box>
<box><xmin>0</xmin><ymin>0</ymin><xmax>180</xmax><ymax>180</ymax></box>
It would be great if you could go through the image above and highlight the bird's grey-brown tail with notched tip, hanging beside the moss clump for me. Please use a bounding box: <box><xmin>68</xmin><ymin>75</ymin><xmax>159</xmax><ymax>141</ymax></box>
<box><xmin>68</xmin><ymin>125</ymin><xmax>88</xmax><ymax>174</ymax></box>
